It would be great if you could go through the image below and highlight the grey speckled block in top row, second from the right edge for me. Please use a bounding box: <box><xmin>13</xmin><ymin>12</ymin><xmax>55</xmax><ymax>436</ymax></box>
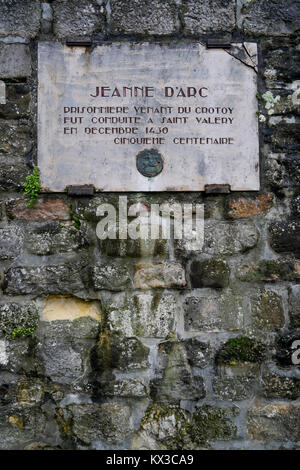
<box><xmin>182</xmin><ymin>0</ymin><xmax>235</xmax><ymax>34</ymax></box>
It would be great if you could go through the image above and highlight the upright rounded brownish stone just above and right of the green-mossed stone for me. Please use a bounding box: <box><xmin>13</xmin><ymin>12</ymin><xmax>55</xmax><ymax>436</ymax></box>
<box><xmin>251</xmin><ymin>290</ymin><xmax>285</xmax><ymax>331</ymax></box>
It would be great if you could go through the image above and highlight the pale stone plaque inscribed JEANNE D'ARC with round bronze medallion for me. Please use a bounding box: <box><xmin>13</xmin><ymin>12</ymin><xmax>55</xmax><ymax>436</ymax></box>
<box><xmin>38</xmin><ymin>43</ymin><xmax>259</xmax><ymax>191</ymax></box>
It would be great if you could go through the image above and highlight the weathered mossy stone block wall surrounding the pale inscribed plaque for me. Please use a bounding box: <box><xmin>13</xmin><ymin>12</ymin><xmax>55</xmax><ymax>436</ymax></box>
<box><xmin>0</xmin><ymin>0</ymin><xmax>300</xmax><ymax>449</ymax></box>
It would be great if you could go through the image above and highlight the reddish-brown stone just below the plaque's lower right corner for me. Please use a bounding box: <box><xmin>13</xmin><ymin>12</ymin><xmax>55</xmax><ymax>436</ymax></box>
<box><xmin>227</xmin><ymin>194</ymin><xmax>273</xmax><ymax>219</ymax></box>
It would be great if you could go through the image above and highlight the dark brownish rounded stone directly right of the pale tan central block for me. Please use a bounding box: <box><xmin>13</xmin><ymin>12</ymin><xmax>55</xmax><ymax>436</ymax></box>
<box><xmin>190</xmin><ymin>259</ymin><xmax>230</xmax><ymax>288</ymax></box>
